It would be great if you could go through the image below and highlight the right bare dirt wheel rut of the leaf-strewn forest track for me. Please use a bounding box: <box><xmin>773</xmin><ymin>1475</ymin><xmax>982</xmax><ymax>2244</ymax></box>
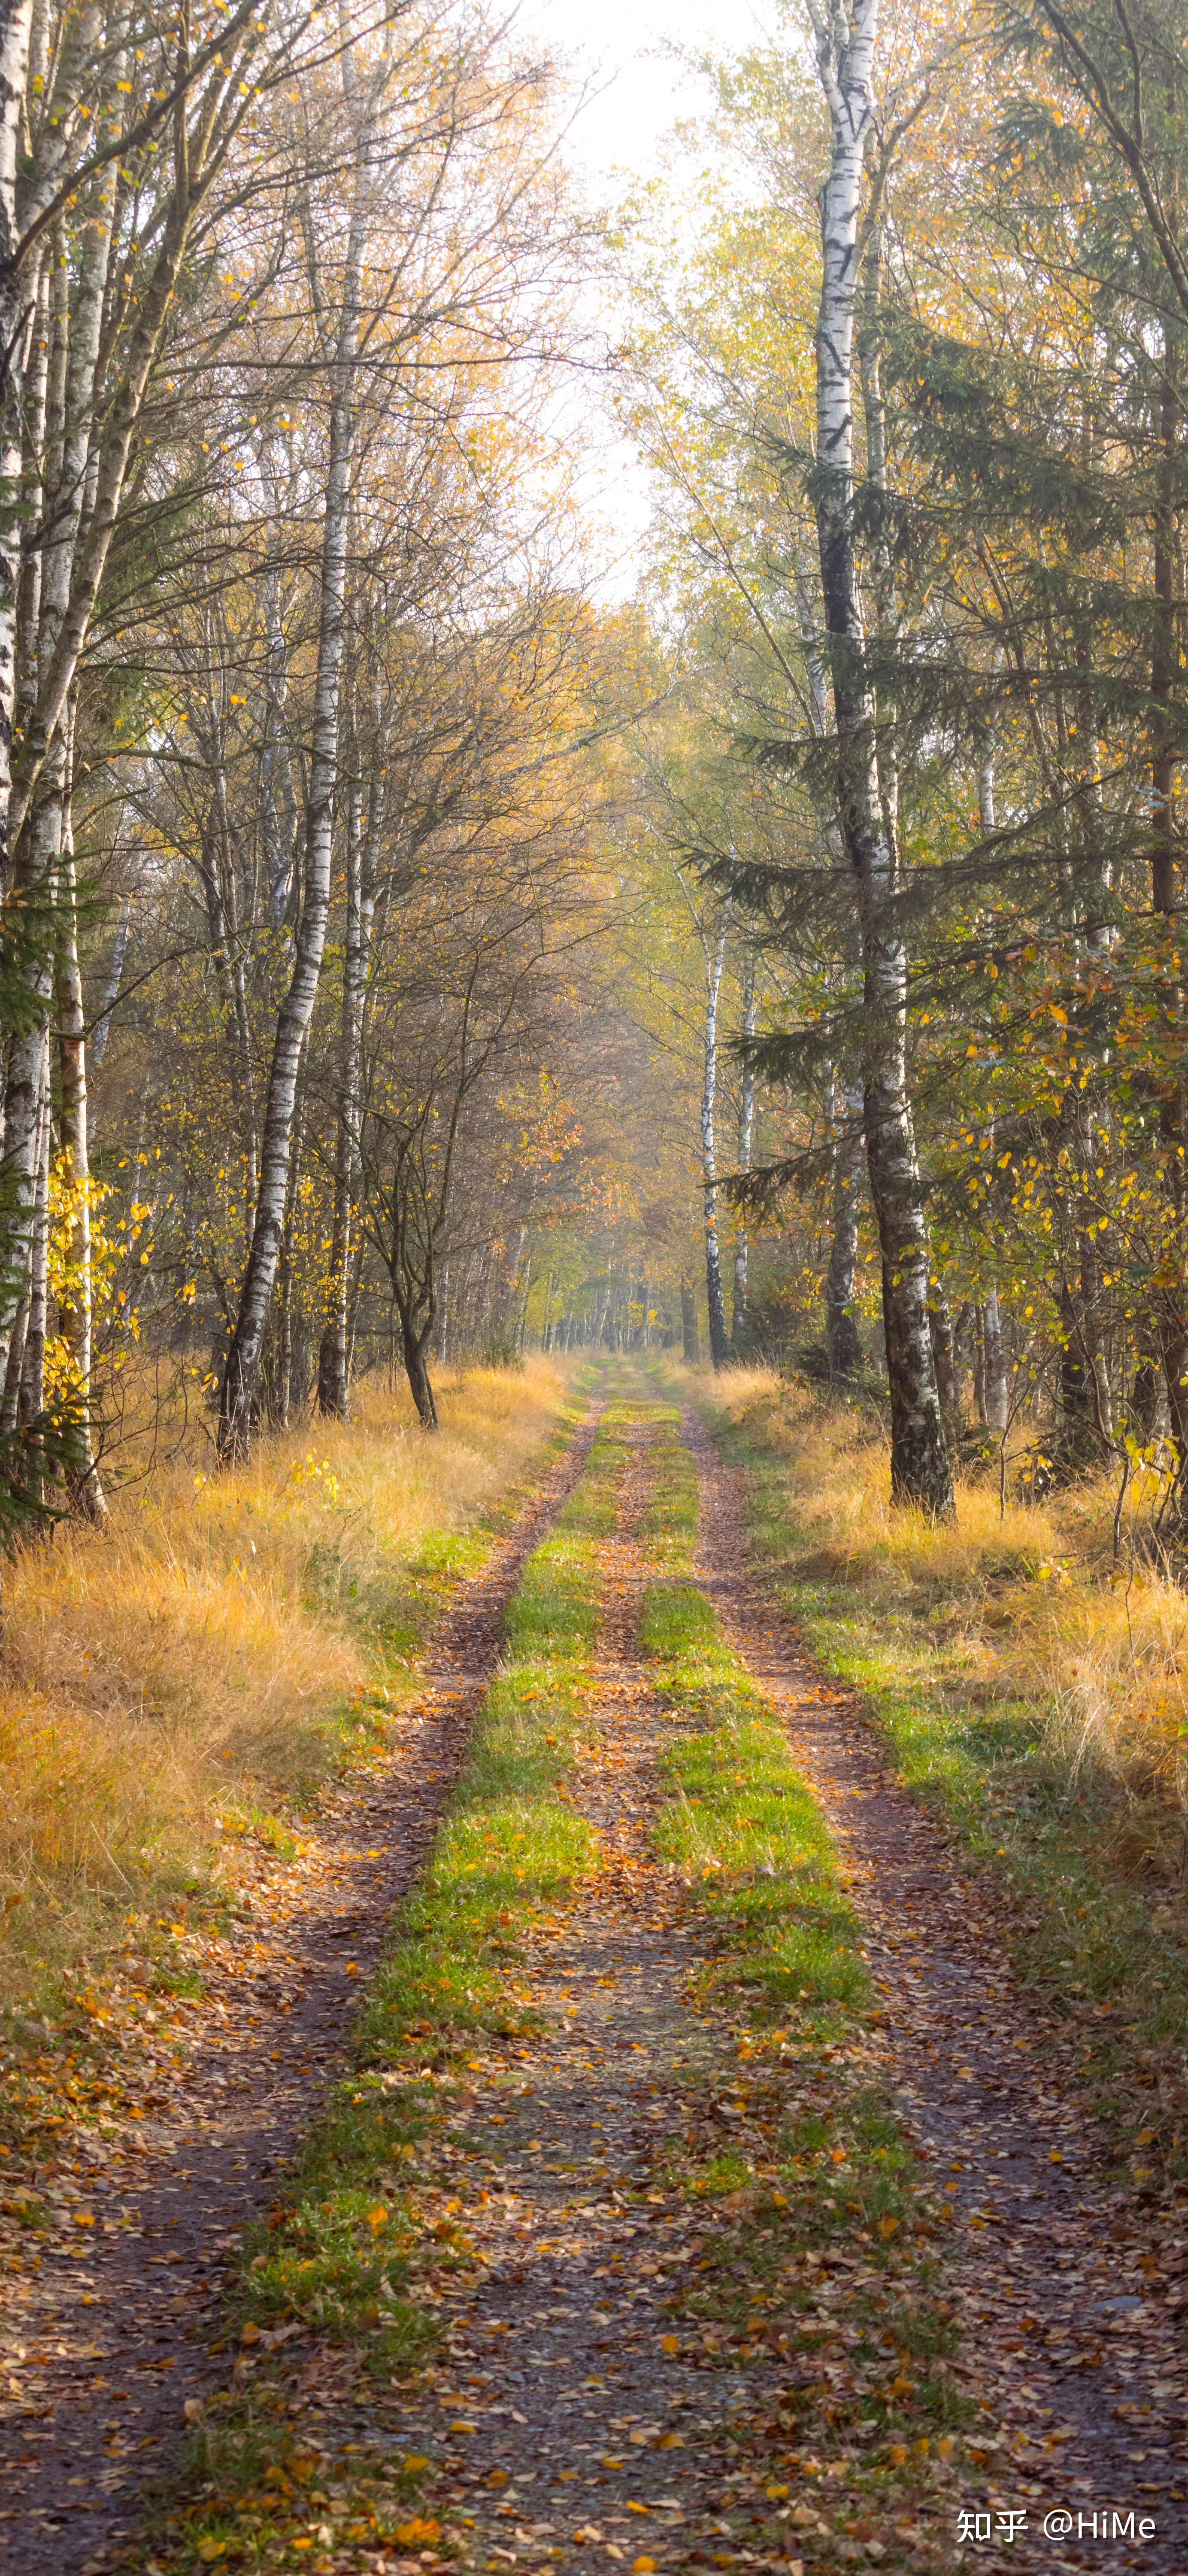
<box><xmin>685</xmin><ymin>1417</ymin><xmax>1188</xmax><ymax>2576</ymax></box>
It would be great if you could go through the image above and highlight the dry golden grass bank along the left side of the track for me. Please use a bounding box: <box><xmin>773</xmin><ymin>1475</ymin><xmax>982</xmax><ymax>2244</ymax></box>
<box><xmin>0</xmin><ymin>1360</ymin><xmax>574</xmax><ymax>1994</ymax></box>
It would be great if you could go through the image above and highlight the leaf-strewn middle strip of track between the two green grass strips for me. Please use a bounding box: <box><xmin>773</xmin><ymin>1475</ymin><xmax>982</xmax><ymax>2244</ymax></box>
<box><xmin>394</xmin><ymin>1430</ymin><xmax>788</xmax><ymax>2571</ymax></box>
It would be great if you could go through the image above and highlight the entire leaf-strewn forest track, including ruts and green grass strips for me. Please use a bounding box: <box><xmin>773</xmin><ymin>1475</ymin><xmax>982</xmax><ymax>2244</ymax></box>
<box><xmin>0</xmin><ymin>1365</ymin><xmax>1188</xmax><ymax>2576</ymax></box>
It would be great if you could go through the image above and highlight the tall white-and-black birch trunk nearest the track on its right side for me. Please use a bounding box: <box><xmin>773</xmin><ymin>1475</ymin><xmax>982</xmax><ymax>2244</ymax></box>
<box><xmin>809</xmin><ymin>0</ymin><xmax>954</xmax><ymax>1517</ymax></box>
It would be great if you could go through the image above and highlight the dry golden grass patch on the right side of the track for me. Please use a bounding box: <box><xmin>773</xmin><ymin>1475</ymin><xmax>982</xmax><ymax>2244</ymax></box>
<box><xmin>683</xmin><ymin>1368</ymin><xmax>1188</xmax><ymax>1814</ymax></box>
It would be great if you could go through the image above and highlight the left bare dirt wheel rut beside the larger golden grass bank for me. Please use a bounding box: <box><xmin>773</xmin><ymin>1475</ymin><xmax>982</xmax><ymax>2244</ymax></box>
<box><xmin>0</xmin><ymin>1406</ymin><xmax>598</xmax><ymax>2576</ymax></box>
